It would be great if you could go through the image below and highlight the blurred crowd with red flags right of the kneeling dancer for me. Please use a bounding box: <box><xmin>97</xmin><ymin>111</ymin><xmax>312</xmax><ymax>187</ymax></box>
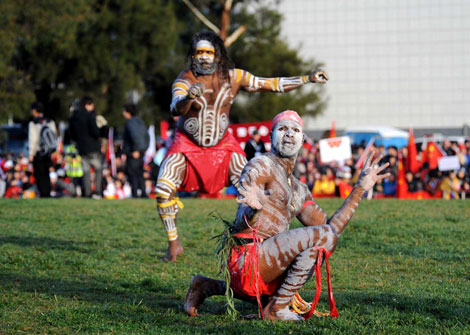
<box><xmin>294</xmin><ymin>140</ymin><xmax>470</xmax><ymax>199</ymax></box>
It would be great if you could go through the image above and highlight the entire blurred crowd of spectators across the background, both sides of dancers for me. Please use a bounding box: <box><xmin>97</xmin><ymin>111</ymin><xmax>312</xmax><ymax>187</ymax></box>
<box><xmin>0</xmin><ymin>97</ymin><xmax>470</xmax><ymax>199</ymax></box>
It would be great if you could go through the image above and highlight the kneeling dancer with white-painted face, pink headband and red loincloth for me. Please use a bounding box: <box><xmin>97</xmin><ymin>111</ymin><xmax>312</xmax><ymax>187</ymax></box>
<box><xmin>184</xmin><ymin>111</ymin><xmax>388</xmax><ymax>320</ymax></box>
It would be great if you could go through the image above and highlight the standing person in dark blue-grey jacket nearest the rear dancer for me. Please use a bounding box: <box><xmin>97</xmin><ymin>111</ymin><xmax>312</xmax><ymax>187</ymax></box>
<box><xmin>122</xmin><ymin>104</ymin><xmax>149</xmax><ymax>198</ymax></box>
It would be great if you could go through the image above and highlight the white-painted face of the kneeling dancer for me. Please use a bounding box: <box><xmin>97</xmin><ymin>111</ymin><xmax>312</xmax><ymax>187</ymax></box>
<box><xmin>271</xmin><ymin>120</ymin><xmax>304</xmax><ymax>157</ymax></box>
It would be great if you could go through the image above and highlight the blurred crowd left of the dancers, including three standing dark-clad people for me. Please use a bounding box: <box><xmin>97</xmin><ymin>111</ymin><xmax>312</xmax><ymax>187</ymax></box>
<box><xmin>0</xmin><ymin>97</ymin><xmax>163</xmax><ymax>199</ymax></box>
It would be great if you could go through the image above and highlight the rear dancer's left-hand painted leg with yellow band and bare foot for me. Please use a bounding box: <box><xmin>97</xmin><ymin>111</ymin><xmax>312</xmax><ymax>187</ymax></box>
<box><xmin>156</xmin><ymin>154</ymin><xmax>186</xmax><ymax>262</ymax></box>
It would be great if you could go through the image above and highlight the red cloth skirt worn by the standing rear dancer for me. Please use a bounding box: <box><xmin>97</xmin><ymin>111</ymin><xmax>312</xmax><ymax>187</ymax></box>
<box><xmin>167</xmin><ymin>131</ymin><xmax>246</xmax><ymax>194</ymax></box>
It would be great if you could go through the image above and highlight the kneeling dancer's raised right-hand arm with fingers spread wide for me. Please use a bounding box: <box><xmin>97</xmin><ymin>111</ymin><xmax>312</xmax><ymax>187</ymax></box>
<box><xmin>297</xmin><ymin>152</ymin><xmax>390</xmax><ymax>235</ymax></box>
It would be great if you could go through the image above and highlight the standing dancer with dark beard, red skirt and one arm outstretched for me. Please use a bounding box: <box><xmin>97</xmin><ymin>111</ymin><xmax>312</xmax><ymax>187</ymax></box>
<box><xmin>156</xmin><ymin>32</ymin><xmax>328</xmax><ymax>261</ymax></box>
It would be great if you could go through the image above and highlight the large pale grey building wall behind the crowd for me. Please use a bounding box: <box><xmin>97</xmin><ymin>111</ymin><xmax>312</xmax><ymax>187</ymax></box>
<box><xmin>277</xmin><ymin>0</ymin><xmax>470</xmax><ymax>136</ymax></box>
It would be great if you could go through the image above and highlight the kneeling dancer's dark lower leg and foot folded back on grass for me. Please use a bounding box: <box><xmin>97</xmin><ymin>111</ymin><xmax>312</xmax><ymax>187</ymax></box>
<box><xmin>184</xmin><ymin>275</ymin><xmax>226</xmax><ymax>316</ymax></box>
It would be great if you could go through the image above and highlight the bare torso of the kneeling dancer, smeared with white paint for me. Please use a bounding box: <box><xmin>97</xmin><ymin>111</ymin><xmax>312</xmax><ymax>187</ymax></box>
<box><xmin>235</xmin><ymin>153</ymin><xmax>309</xmax><ymax>238</ymax></box>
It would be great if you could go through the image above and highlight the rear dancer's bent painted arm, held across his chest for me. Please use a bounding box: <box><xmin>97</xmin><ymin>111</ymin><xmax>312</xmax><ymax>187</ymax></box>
<box><xmin>170</xmin><ymin>79</ymin><xmax>213</xmax><ymax>116</ymax></box>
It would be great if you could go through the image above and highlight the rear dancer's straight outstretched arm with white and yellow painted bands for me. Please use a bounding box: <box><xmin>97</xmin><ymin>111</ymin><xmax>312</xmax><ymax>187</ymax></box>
<box><xmin>233</xmin><ymin>69</ymin><xmax>329</xmax><ymax>92</ymax></box>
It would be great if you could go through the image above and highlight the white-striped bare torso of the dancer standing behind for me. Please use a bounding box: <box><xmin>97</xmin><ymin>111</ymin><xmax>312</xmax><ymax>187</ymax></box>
<box><xmin>175</xmin><ymin>70</ymin><xmax>239</xmax><ymax>147</ymax></box>
